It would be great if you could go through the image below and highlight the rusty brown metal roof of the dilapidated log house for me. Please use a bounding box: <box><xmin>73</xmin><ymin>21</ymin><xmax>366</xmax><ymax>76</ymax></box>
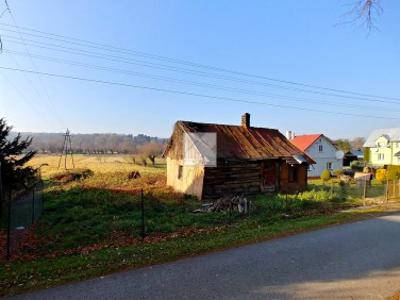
<box><xmin>165</xmin><ymin>121</ymin><xmax>314</xmax><ymax>164</ymax></box>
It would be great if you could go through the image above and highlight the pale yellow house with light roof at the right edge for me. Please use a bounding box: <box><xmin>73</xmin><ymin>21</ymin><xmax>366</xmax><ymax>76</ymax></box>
<box><xmin>364</xmin><ymin>128</ymin><xmax>400</xmax><ymax>167</ymax></box>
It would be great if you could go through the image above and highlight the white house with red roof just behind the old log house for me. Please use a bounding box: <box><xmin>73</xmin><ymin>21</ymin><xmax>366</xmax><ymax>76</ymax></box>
<box><xmin>289</xmin><ymin>132</ymin><xmax>343</xmax><ymax>177</ymax></box>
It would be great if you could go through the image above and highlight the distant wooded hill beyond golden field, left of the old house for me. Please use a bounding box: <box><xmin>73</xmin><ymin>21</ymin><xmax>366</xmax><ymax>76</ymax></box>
<box><xmin>11</xmin><ymin>132</ymin><xmax>167</xmax><ymax>153</ymax></box>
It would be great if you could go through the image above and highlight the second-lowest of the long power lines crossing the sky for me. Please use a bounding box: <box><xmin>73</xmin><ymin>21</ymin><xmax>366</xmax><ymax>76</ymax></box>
<box><xmin>4</xmin><ymin>50</ymin><xmax>400</xmax><ymax>113</ymax></box>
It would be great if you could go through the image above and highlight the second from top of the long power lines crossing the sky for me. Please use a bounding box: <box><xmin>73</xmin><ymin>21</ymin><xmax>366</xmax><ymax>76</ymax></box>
<box><xmin>2</xmin><ymin>36</ymin><xmax>400</xmax><ymax>103</ymax></box>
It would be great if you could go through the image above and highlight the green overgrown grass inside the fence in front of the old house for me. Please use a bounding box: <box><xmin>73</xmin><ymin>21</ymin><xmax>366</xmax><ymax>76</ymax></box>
<box><xmin>27</xmin><ymin>184</ymin><xmax>356</xmax><ymax>255</ymax></box>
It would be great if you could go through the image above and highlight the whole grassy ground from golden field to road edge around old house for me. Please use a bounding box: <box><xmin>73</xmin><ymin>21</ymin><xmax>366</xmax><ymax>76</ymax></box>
<box><xmin>0</xmin><ymin>155</ymin><xmax>394</xmax><ymax>295</ymax></box>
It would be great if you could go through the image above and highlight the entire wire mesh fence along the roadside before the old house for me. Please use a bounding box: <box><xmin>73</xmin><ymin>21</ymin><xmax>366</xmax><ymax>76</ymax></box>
<box><xmin>3</xmin><ymin>178</ymin><xmax>400</xmax><ymax>259</ymax></box>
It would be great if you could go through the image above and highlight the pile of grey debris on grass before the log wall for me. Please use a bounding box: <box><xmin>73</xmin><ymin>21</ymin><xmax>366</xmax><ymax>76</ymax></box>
<box><xmin>193</xmin><ymin>195</ymin><xmax>251</xmax><ymax>214</ymax></box>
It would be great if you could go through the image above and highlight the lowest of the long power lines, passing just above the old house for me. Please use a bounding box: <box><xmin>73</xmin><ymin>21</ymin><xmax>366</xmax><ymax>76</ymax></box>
<box><xmin>0</xmin><ymin>66</ymin><xmax>400</xmax><ymax>120</ymax></box>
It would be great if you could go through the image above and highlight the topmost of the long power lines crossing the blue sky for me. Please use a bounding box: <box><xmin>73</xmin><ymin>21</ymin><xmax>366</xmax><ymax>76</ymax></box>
<box><xmin>0</xmin><ymin>23</ymin><xmax>400</xmax><ymax>100</ymax></box>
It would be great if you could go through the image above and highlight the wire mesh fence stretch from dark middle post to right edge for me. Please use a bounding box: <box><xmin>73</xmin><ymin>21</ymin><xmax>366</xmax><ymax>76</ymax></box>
<box><xmin>117</xmin><ymin>177</ymin><xmax>400</xmax><ymax>239</ymax></box>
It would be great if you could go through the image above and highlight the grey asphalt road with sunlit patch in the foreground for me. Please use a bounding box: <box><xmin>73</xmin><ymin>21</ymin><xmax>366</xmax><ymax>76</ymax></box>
<box><xmin>9</xmin><ymin>214</ymin><xmax>400</xmax><ymax>300</ymax></box>
